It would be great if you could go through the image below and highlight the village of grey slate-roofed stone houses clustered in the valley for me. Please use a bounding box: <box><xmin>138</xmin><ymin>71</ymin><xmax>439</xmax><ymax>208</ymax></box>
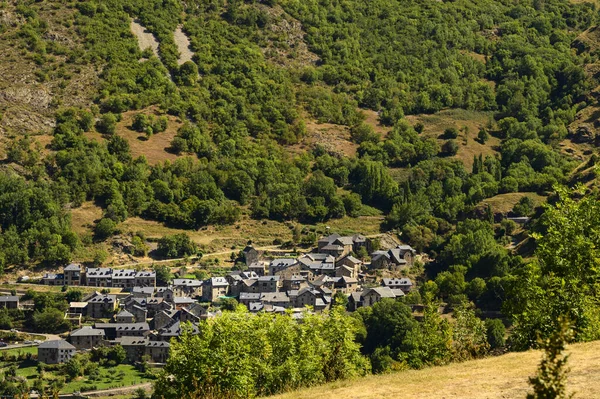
<box><xmin>0</xmin><ymin>234</ymin><xmax>417</xmax><ymax>364</ymax></box>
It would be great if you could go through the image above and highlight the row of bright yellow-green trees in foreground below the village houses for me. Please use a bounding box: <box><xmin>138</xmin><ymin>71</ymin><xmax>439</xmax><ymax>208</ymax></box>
<box><xmin>155</xmin><ymin>308</ymin><xmax>368</xmax><ymax>398</ymax></box>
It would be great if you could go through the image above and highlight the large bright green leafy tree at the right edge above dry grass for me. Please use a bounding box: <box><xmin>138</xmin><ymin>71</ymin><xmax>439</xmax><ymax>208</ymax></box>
<box><xmin>504</xmin><ymin>188</ymin><xmax>600</xmax><ymax>349</ymax></box>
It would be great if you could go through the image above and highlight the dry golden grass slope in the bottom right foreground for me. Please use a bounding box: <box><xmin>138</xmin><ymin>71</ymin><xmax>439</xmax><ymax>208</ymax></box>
<box><xmin>273</xmin><ymin>342</ymin><xmax>600</xmax><ymax>399</ymax></box>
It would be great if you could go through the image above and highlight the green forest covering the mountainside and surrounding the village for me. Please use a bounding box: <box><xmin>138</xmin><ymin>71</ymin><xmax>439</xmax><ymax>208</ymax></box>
<box><xmin>0</xmin><ymin>0</ymin><xmax>600</xmax><ymax>398</ymax></box>
